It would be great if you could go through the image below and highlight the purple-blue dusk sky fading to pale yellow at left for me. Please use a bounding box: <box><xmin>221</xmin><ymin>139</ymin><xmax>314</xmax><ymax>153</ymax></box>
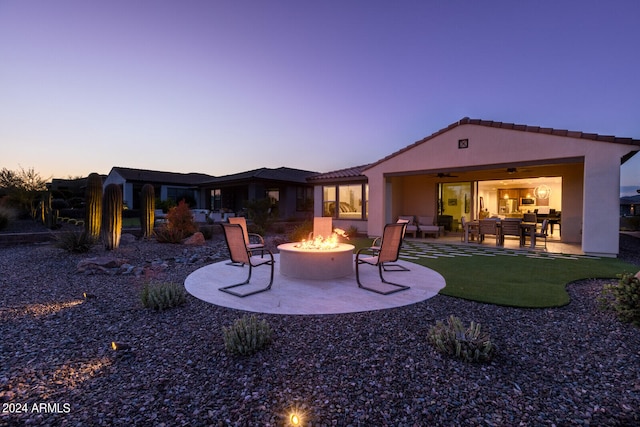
<box><xmin>0</xmin><ymin>0</ymin><xmax>640</xmax><ymax>188</ymax></box>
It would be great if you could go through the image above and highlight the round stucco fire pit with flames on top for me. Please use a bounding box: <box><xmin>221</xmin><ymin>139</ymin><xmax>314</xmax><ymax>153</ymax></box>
<box><xmin>278</xmin><ymin>243</ymin><xmax>355</xmax><ymax>280</ymax></box>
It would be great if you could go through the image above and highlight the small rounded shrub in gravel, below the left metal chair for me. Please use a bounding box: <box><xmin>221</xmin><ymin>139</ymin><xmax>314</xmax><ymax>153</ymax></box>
<box><xmin>222</xmin><ymin>315</ymin><xmax>272</xmax><ymax>356</ymax></box>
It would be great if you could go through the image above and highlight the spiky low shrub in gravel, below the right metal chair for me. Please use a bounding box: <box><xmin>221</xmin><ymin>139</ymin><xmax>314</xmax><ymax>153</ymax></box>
<box><xmin>429</xmin><ymin>316</ymin><xmax>496</xmax><ymax>362</ymax></box>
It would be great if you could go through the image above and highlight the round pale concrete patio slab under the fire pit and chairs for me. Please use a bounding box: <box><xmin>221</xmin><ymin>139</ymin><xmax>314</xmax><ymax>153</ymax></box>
<box><xmin>185</xmin><ymin>254</ymin><xmax>445</xmax><ymax>315</ymax></box>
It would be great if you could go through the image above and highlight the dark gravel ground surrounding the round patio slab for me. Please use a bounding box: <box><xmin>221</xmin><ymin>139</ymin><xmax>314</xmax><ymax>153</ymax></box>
<box><xmin>0</xmin><ymin>224</ymin><xmax>640</xmax><ymax>426</ymax></box>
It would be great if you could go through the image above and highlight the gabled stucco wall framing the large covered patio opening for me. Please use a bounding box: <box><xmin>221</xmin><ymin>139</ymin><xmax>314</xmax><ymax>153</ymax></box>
<box><xmin>363</xmin><ymin>124</ymin><xmax>637</xmax><ymax>256</ymax></box>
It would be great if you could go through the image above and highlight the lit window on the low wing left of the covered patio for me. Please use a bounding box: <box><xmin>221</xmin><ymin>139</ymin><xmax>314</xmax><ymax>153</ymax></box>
<box><xmin>322</xmin><ymin>184</ymin><xmax>369</xmax><ymax>219</ymax></box>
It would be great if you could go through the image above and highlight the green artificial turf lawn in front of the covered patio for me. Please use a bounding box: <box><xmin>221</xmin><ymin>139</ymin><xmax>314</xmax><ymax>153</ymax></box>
<box><xmin>350</xmin><ymin>239</ymin><xmax>640</xmax><ymax>308</ymax></box>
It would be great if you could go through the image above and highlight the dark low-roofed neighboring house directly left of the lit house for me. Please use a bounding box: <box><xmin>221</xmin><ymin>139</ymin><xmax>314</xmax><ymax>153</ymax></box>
<box><xmin>198</xmin><ymin>167</ymin><xmax>316</xmax><ymax>219</ymax></box>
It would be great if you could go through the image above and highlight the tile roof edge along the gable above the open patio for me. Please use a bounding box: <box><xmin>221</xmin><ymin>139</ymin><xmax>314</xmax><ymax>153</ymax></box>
<box><xmin>363</xmin><ymin>117</ymin><xmax>640</xmax><ymax>170</ymax></box>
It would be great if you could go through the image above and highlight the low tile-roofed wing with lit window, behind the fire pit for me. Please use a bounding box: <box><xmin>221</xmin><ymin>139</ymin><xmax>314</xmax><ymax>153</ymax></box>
<box><xmin>307</xmin><ymin>165</ymin><xmax>369</xmax><ymax>233</ymax></box>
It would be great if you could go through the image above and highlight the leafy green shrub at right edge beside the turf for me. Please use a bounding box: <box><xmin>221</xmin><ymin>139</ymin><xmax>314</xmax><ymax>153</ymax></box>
<box><xmin>600</xmin><ymin>273</ymin><xmax>640</xmax><ymax>326</ymax></box>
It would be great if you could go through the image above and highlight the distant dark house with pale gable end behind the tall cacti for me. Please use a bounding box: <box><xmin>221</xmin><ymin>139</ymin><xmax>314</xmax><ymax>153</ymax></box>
<box><xmin>103</xmin><ymin>166</ymin><xmax>213</xmax><ymax>209</ymax></box>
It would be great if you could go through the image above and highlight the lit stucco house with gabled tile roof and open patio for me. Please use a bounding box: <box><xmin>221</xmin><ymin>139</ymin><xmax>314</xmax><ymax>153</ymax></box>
<box><xmin>310</xmin><ymin>118</ymin><xmax>640</xmax><ymax>256</ymax></box>
